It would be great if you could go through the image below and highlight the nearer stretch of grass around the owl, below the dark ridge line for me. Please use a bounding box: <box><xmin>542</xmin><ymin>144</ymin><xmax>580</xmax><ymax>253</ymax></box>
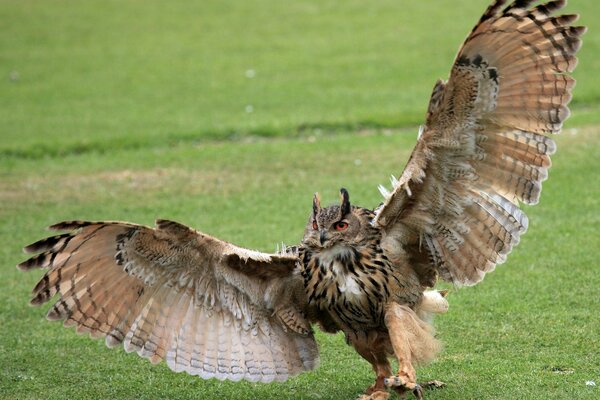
<box><xmin>0</xmin><ymin>128</ymin><xmax>600</xmax><ymax>399</ymax></box>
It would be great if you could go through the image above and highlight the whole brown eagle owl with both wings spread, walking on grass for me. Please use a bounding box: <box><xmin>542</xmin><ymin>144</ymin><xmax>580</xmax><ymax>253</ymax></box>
<box><xmin>18</xmin><ymin>0</ymin><xmax>585</xmax><ymax>399</ymax></box>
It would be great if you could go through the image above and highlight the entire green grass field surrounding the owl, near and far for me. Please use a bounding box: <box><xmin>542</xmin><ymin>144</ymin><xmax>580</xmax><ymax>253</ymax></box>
<box><xmin>0</xmin><ymin>0</ymin><xmax>600</xmax><ymax>399</ymax></box>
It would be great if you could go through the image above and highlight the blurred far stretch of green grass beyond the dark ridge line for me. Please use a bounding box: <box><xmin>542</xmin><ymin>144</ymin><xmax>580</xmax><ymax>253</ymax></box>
<box><xmin>0</xmin><ymin>0</ymin><xmax>600</xmax><ymax>156</ymax></box>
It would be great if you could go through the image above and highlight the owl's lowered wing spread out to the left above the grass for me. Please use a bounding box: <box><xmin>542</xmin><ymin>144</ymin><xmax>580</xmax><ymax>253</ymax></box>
<box><xmin>18</xmin><ymin>220</ymin><xmax>318</xmax><ymax>382</ymax></box>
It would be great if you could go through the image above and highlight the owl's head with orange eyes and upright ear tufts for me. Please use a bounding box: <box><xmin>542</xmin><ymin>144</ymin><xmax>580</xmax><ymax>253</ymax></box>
<box><xmin>302</xmin><ymin>188</ymin><xmax>374</xmax><ymax>249</ymax></box>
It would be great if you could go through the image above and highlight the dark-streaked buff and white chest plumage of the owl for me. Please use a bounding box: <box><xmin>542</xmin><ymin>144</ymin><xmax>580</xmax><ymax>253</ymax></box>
<box><xmin>302</xmin><ymin>243</ymin><xmax>396</xmax><ymax>331</ymax></box>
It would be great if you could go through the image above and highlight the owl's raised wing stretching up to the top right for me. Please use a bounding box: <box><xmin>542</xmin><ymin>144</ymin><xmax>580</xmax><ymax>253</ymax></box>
<box><xmin>374</xmin><ymin>0</ymin><xmax>585</xmax><ymax>286</ymax></box>
